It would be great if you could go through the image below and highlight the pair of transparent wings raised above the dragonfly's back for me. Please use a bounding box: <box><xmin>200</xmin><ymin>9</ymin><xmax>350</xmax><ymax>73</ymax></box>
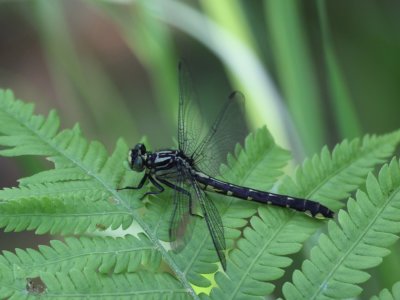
<box><xmin>178</xmin><ymin>61</ymin><xmax>248</xmax><ymax>177</ymax></box>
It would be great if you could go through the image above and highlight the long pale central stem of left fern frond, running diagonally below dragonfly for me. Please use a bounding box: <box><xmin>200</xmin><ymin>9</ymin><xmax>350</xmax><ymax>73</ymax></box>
<box><xmin>1</xmin><ymin>105</ymin><xmax>199</xmax><ymax>299</ymax></box>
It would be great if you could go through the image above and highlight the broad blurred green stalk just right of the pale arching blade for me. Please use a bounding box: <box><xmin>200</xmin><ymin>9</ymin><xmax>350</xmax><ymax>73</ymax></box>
<box><xmin>265</xmin><ymin>0</ymin><xmax>326</xmax><ymax>154</ymax></box>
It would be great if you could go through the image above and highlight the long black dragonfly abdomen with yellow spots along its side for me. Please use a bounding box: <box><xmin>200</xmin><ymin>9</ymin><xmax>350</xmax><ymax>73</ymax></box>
<box><xmin>196</xmin><ymin>173</ymin><xmax>334</xmax><ymax>219</ymax></box>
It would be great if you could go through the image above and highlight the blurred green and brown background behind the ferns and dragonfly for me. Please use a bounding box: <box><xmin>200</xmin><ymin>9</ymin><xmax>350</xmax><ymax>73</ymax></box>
<box><xmin>0</xmin><ymin>0</ymin><xmax>400</xmax><ymax>296</ymax></box>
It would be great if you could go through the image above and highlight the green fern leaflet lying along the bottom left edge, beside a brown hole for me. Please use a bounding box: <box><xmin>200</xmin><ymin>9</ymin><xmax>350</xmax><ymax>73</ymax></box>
<box><xmin>0</xmin><ymin>266</ymin><xmax>190</xmax><ymax>300</ymax></box>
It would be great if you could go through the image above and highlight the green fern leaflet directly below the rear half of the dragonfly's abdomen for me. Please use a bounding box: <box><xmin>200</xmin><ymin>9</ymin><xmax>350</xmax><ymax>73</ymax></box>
<box><xmin>210</xmin><ymin>207</ymin><xmax>320</xmax><ymax>299</ymax></box>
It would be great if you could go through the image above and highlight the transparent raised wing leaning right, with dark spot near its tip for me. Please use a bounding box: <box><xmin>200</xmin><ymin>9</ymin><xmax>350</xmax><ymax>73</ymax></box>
<box><xmin>192</xmin><ymin>92</ymin><xmax>248</xmax><ymax>176</ymax></box>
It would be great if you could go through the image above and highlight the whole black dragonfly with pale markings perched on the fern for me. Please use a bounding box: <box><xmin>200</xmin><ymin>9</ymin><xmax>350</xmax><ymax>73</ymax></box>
<box><xmin>121</xmin><ymin>63</ymin><xmax>333</xmax><ymax>270</ymax></box>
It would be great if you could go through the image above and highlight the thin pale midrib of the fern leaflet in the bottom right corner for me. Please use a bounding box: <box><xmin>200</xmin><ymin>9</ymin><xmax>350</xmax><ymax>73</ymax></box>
<box><xmin>310</xmin><ymin>188</ymin><xmax>400</xmax><ymax>299</ymax></box>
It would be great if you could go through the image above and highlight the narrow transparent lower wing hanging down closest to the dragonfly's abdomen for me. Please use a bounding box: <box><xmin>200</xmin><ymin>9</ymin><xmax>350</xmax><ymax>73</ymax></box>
<box><xmin>195</xmin><ymin>185</ymin><xmax>226</xmax><ymax>271</ymax></box>
